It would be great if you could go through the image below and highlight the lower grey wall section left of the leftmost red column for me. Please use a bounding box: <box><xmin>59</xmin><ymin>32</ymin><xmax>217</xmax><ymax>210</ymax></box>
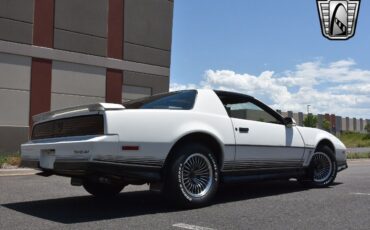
<box><xmin>0</xmin><ymin>53</ymin><xmax>31</xmax><ymax>153</ymax></box>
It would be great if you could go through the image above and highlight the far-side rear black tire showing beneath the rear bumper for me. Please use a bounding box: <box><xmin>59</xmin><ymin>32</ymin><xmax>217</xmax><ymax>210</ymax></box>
<box><xmin>82</xmin><ymin>180</ymin><xmax>126</xmax><ymax>198</ymax></box>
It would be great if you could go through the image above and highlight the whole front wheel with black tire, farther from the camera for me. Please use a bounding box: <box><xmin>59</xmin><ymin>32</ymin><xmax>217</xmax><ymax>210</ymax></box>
<box><xmin>300</xmin><ymin>146</ymin><xmax>337</xmax><ymax>188</ymax></box>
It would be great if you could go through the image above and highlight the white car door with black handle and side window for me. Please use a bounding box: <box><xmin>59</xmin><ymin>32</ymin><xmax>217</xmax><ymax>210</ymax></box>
<box><xmin>225</xmin><ymin>97</ymin><xmax>304</xmax><ymax>170</ymax></box>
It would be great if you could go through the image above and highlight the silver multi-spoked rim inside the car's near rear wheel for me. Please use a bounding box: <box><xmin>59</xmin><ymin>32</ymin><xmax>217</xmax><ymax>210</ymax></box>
<box><xmin>181</xmin><ymin>153</ymin><xmax>213</xmax><ymax>198</ymax></box>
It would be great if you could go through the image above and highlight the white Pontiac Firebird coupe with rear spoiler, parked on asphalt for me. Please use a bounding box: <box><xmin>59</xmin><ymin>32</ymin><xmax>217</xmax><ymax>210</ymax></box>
<box><xmin>21</xmin><ymin>89</ymin><xmax>347</xmax><ymax>207</ymax></box>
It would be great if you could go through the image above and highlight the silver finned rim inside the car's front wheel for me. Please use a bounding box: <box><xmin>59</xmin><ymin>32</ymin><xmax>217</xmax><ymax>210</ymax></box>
<box><xmin>312</xmin><ymin>152</ymin><xmax>333</xmax><ymax>183</ymax></box>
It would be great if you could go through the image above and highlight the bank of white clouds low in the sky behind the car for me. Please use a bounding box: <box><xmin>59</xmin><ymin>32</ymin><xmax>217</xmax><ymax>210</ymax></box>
<box><xmin>170</xmin><ymin>59</ymin><xmax>370</xmax><ymax>118</ymax></box>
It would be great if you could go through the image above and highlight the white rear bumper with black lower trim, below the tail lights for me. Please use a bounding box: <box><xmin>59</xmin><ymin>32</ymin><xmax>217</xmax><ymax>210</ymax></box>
<box><xmin>21</xmin><ymin>135</ymin><xmax>161</xmax><ymax>182</ymax></box>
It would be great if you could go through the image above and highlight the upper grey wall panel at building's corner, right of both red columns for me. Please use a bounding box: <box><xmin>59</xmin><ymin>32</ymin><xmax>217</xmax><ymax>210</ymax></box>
<box><xmin>123</xmin><ymin>0</ymin><xmax>173</xmax><ymax>67</ymax></box>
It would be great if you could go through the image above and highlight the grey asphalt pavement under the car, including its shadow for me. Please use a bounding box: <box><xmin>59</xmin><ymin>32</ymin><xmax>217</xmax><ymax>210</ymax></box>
<box><xmin>0</xmin><ymin>160</ymin><xmax>370</xmax><ymax>230</ymax></box>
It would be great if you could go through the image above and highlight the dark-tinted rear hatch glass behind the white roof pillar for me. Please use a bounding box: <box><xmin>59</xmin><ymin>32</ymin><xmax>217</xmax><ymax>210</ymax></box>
<box><xmin>123</xmin><ymin>90</ymin><xmax>197</xmax><ymax>110</ymax></box>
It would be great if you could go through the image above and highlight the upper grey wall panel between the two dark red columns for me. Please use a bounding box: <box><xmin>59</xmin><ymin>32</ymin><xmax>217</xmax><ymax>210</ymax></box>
<box><xmin>54</xmin><ymin>0</ymin><xmax>108</xmax><ymax>56</ymax></box>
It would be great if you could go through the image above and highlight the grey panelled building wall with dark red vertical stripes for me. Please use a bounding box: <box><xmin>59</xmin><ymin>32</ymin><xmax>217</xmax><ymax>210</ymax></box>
<box><xmin>0</xmin><ymin>0</ymin><xmax>174</xmax><ymax>153</ymax></box>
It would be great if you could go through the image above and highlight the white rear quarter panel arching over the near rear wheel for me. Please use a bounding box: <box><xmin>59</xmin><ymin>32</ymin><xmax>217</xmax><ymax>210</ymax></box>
<box><xmin>101</xmin><ymin>109</ymin><xmax>235</xmax><ymax>165</ymax></box>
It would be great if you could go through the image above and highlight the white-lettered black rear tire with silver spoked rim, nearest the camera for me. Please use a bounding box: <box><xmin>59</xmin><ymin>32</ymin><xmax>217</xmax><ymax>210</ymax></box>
<box><xmin>164</xmin><ymin>143</ymin><xmax>219</xmax><ymax>208</ymax></box>
